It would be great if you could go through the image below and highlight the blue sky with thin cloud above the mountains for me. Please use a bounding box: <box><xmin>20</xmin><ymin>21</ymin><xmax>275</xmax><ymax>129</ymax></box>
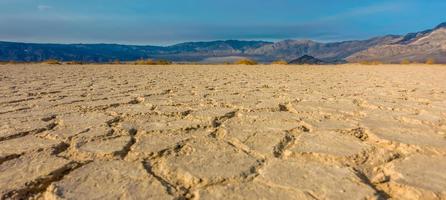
<box><xmin>0</xmin><ymin>0</ymin><xmax>446</xmax><ymax>45</ymax></box>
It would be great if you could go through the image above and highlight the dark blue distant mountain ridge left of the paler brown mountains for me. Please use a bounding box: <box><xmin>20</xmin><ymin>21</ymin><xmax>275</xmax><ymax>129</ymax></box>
<box><xmin>0</xmin><ymin>40</ymin><xmax>271</xmax><ymax>62</ymax></box>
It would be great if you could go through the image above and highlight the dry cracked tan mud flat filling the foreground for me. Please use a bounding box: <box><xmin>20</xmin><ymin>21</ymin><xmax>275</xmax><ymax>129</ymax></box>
<box><xmin>0</xmin><ymin>65</ymin><xmax>446</xmax><ymax>200</ymax></box>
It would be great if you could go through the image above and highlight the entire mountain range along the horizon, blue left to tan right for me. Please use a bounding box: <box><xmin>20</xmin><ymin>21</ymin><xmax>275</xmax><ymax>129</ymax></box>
<box><xmin>0</xmin><ymin>23</ymin><xmax>446</xmax><ymax>63</ymax></box>
